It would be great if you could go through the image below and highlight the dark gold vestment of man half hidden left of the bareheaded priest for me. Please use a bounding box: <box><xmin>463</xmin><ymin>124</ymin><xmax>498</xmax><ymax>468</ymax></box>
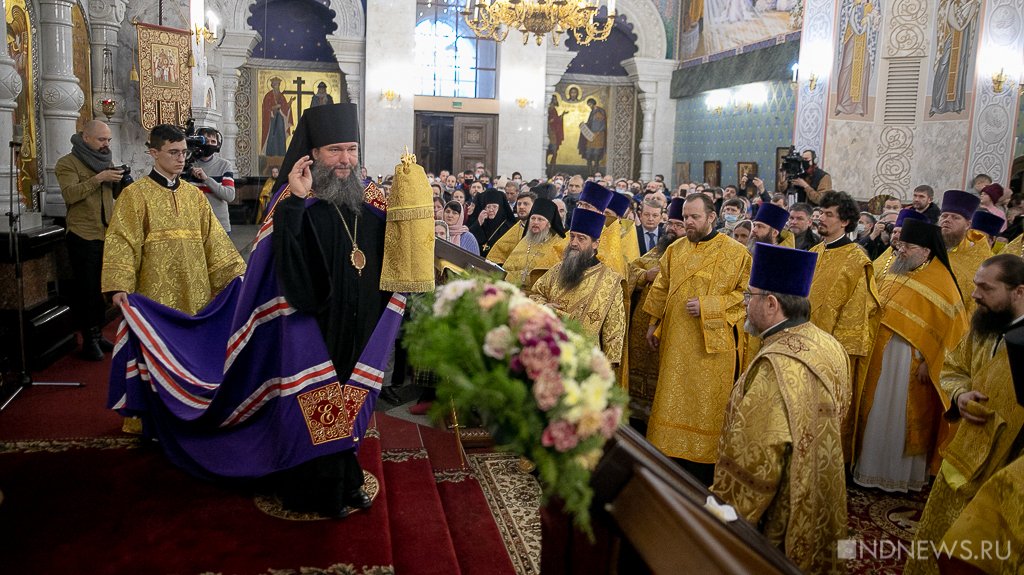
<box><xmin>626</xmin><ymin>249</ymin><xmax>662</xmax><ymax>422</ymax></box>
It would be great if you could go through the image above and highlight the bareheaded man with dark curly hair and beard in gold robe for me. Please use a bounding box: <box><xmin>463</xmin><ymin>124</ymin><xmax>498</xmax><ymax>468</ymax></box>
<box><xmin>808</xmin><ymin>191</ymin><xmax>879</xmax><ymax>460</ymax></box>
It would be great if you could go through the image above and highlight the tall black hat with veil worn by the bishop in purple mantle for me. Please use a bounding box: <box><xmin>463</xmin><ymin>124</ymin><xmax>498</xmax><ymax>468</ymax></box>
<box><xmin>274</xmin><ymin>103</ymin><xmax>359</xmax><ymax>189</ymax></box>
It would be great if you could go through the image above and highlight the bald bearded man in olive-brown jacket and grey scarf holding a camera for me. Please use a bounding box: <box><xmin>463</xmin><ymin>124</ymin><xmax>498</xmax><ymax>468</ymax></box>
<box><xmin>55</xmin><ymin>120</ymin><xmax>132</xmax><ymax>361</ymax></box>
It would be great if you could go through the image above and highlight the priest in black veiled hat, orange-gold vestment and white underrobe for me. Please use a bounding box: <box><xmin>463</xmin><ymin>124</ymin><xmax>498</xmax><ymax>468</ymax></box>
<box><xmin>851</xmin><ymin>220</ymin><xmax>968</xmax><ymax>492</ymax></box>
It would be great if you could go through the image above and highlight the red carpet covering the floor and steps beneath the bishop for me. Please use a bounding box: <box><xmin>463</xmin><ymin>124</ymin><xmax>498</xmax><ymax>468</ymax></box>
<box><xmin>0</xmin><ymin>326</ymin><xmax>515</xmax><ymax>575</ymax></box>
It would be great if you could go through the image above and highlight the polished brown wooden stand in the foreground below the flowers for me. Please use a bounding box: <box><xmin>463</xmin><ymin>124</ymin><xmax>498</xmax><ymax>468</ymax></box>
<box><xmin>541</xmin><ymin>427</ymin><xmax>801</xmax><ymax>575</ymax></box>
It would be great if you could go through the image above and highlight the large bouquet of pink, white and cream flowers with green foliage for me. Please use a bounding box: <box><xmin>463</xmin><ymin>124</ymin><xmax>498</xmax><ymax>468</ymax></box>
<box><xmin>404</xmin><ymin>277</ymin><xmax>628</xmax><ymax>533</ymax></box>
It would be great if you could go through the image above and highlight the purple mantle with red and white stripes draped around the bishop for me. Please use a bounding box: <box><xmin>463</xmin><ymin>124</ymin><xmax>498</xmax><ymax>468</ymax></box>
<box><xmin>109</xmin><ymin>212</ymin><xmax>406</xmax><ymax>478</ymax></box>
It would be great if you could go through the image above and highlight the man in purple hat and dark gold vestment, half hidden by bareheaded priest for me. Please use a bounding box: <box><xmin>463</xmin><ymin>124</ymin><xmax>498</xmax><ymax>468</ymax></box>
<box><xmin>626</xmin><ymin>197</ymin><xmax>683</xmax><ymax>426</ymax></box>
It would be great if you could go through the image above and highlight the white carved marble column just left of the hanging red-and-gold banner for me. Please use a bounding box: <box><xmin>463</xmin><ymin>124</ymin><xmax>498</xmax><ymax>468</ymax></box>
<box><xmin>89</xmin><ymin>0</ymin><xmax>128</xmax><ymax>164</ymax></box>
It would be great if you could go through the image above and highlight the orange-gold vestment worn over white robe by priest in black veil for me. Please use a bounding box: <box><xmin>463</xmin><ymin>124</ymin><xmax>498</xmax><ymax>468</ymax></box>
<box><xmin>850</xmin><ymin>258</ymin><xmax>968</xmax><ymax>466</ymax></box>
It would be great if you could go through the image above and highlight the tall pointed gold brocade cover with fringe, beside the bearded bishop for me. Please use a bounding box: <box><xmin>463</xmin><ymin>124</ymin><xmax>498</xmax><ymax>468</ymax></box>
<box><xmin>381</xmin><ymin>150</ymin><xmax>434</xmax><ymax>294</ymax></box>
